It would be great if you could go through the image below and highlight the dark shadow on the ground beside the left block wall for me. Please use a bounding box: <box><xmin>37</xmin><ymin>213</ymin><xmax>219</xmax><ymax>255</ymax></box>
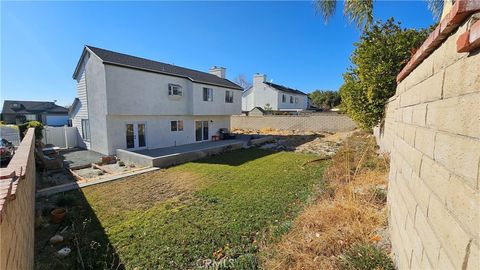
<box><xmin>35</xmin><ymin>189</ymin><xmax>124</xmax><ymax>270</ymax></box>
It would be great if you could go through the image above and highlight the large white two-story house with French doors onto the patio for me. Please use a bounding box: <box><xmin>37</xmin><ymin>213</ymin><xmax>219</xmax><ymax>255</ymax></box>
<box><xmin>71</xmin><ymin>46</ymin><xmax>242</xmax><ymax>155</ymax></box>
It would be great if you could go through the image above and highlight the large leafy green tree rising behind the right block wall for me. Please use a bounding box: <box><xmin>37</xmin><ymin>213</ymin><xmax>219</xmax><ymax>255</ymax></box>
<box><xmin>340</xmin><ymin>18</ymin><xmax>428</xmax><ymax>129</ymax></box>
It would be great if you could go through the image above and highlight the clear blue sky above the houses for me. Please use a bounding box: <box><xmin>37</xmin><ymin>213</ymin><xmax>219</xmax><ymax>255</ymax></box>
<box><xmin>0</xmin><ymin>1</ymin><xmax>434</xmax><ymax>106</ymax></box>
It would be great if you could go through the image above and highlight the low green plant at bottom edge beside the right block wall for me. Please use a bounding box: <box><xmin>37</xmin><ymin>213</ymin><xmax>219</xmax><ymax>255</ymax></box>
<box><xmin>339</xmin><ymin>244</ymin><xmax>395</xmax><ymax>270</ymax></box>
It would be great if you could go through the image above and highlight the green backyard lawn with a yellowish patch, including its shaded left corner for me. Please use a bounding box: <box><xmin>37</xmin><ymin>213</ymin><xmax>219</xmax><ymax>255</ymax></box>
<box><xmin>36</xmin><ymin>149</ymin><xmax>324</xmax><ymax>269</ymax></box>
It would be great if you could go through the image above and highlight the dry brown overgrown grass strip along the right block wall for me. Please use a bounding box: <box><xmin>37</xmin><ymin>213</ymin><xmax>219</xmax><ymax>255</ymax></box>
<box><xmin>262</xmin><ymin>132</ymin><xmax>388</xmax><ymax>269</ymax></box>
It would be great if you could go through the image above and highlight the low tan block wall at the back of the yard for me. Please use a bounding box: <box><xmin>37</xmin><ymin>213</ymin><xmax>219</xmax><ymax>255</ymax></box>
<box><xmin>230</xmin><ymin>113</ymin><xmax>355</xmax><ymax>132</ymax></box>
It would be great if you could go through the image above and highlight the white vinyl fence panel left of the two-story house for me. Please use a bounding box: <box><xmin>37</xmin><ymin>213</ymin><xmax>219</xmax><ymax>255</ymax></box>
<box><xmin>42</xmin><ymin>126</ymin><xmax>79</xmax><ymax>148</ymax></box>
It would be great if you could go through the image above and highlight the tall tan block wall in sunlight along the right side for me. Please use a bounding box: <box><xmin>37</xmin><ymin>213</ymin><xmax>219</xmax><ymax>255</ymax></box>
<box><xmin>375</xmin><ymin>13</ymin><xmax>480</xmax><ymax>269</ymax></box>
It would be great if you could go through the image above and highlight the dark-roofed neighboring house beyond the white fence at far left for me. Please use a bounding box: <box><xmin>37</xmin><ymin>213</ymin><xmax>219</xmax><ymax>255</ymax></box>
<box><xmin>2</xmin><ymin>100</ymin><xmax>68</xmax><ymax>126</ymax></box>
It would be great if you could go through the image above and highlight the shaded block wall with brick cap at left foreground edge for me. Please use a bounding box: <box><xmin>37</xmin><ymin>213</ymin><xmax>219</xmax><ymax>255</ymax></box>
<box><xmin>0</xmin><ymin>129</ymin><xmax>35</xmax><ymax>270</ymax></box>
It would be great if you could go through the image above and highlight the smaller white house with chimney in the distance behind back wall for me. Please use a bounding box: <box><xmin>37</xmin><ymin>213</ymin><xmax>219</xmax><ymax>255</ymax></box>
<box><xmin>242</xmin><ymin>73</ymin><xmax>308</xmax><ymax>112</ymax></box>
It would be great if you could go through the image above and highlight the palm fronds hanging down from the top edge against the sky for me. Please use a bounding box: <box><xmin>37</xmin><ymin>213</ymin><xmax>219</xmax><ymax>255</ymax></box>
<box><xmin>314</xmin><ymin>0</ymin><xmax>446</xmax><ymax>28</ymax></box>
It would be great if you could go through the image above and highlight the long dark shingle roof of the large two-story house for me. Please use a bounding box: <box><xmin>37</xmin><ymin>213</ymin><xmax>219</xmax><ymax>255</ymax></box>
<box><xmin>81</xmin><ymin>45</ymin><xmax>243</xmax><ymax>90</ymax></box>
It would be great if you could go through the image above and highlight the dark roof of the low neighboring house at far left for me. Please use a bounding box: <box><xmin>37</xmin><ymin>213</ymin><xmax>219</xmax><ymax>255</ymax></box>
<box><xmin>2</xmin><ymin>100</ymin><xmax>68</xmax><ymax>114</ymax></box>
